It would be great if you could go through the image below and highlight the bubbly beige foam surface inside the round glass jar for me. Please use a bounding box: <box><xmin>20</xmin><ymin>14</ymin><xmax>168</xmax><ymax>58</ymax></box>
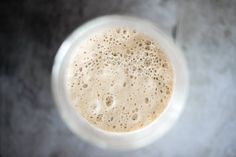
<box><xmin>66</xmin><ymin>28</ymin><xmax>174</xmax><ymax>132</ymax></box>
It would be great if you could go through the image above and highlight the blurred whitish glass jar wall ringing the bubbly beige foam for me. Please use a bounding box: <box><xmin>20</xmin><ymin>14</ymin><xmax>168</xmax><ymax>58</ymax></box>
<box><xmin>52</xmin><ymin>15</ymin><xmax>188</xmax><ymax>150</ymax></box>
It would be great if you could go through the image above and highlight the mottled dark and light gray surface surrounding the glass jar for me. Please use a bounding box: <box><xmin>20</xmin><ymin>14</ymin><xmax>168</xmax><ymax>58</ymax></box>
<box><xmin>0</xmin><ymin>0</ymin><xmax>236</xmax><ymax>157</ymax></box>
